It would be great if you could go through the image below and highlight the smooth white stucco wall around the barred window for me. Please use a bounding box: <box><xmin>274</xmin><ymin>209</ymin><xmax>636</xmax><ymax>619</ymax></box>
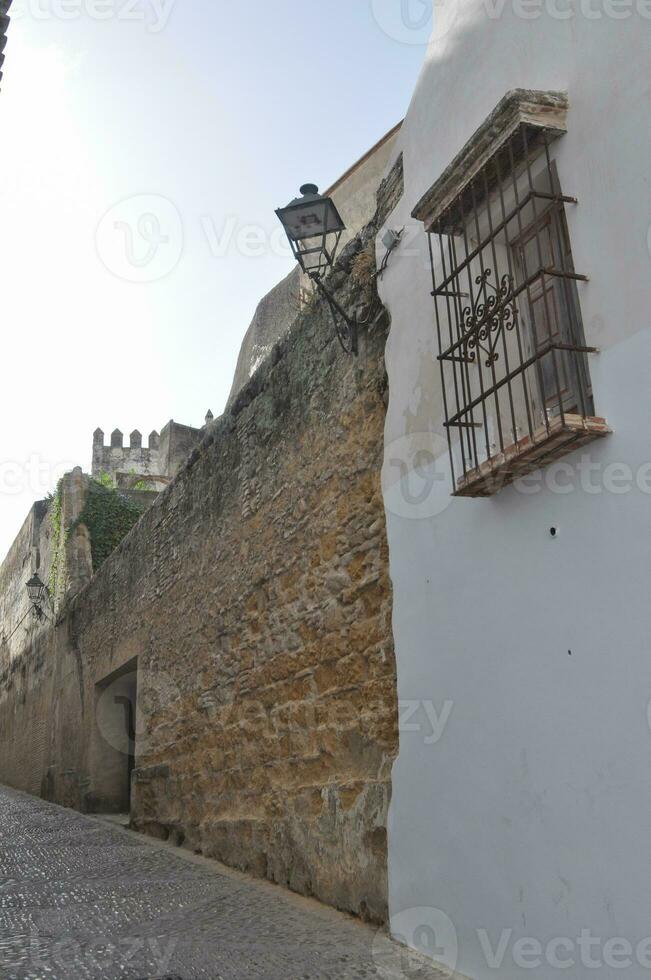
<box><xmin>378</xmin><ymin>0</ymin><xmax>651</xmax><ymax>980</ymax></box>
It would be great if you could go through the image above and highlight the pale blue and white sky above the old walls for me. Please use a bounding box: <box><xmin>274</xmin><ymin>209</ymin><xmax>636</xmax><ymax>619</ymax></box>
<box><xmin>0</xmin><ymin>0</ymin><xmax>432</xmax><ymax>555</ymax></box>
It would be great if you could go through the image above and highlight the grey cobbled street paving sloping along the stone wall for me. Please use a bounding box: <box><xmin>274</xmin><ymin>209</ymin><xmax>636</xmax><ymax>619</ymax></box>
<box><xmin>0</xmin><ymin>787</ymin><xmax>449</xmax><ymax>980</ymax></box>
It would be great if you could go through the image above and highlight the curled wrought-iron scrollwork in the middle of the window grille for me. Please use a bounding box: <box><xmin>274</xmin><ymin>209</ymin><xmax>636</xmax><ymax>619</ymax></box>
<box><xmin>462</xmin><ymin>269</ymin><xmax>518</xmax><ymax>367</ymax></box>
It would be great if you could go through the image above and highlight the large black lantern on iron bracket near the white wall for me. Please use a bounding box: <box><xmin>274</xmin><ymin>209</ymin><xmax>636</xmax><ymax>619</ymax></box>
<box><xmin>276</xmin><ymin>184</ymin><xmax>358</xmax><ymax>354</ymax></box>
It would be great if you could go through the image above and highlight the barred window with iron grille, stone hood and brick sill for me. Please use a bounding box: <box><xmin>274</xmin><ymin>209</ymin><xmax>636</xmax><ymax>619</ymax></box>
<box><xmin>414</xmin><ymin>91</ymin><xmax>610</xmax><ymax>496</ymax></box>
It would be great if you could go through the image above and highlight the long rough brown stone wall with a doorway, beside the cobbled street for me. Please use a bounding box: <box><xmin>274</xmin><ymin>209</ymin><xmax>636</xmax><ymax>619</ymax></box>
<box><xmin>0</xmin><ymin>228</ymin><xmax>397</xmax><ymax>921</ymax></box>
